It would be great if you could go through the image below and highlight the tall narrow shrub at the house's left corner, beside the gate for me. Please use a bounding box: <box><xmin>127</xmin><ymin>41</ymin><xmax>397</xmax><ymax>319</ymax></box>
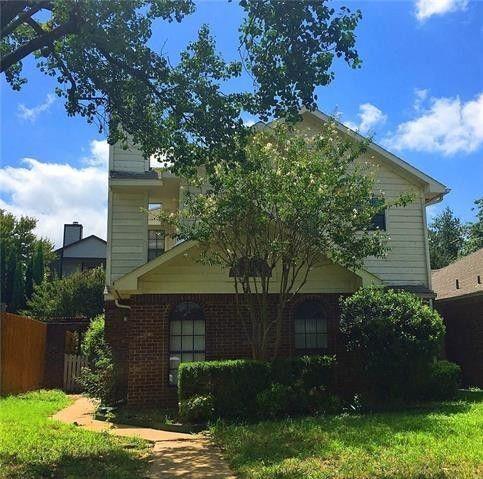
<box><xmin>79</xmin><ymin>316</ymin><xmax>117</xmax><ymax>405</ymax></box>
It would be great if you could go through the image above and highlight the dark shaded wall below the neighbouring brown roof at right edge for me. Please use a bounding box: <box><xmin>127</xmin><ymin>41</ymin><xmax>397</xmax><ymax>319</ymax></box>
<box><xmin>436</xmin><ymin>296</ymin><xmax>483</xmax><ymax>387</ymax></box>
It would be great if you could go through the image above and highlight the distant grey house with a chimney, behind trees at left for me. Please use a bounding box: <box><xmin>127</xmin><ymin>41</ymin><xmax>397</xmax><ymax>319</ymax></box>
<box><xmin>54</xmin><ymin>221</ymin><xmax>106</xmax><ymax>278</ymax></box>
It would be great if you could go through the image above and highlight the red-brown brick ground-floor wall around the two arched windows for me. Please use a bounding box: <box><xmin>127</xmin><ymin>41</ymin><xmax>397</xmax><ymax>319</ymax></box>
<box><xmin>106</xmin><ymin>294</ymin><xmax>340</xmax><ymax>407</ymax></box>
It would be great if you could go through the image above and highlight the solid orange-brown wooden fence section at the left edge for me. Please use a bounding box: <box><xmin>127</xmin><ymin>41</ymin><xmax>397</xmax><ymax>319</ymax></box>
<box><xmin>0</xmin><ymin>312</ymin><xmax>47</xmax><ymax>395</ymax></box>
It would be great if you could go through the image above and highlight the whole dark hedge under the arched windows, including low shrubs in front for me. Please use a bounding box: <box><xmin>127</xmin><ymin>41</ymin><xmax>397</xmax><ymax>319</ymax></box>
<box><xmin>178</xmin><ymin>356</ymin><xmax>335</xmax><ymax>420</ymax></box>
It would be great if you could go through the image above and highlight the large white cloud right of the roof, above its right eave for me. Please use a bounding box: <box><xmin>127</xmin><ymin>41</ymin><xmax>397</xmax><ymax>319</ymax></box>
<box><xmin>383</xmin><ymin>93</ymin><xmax>483</xmax><ymax>156</ymax></box>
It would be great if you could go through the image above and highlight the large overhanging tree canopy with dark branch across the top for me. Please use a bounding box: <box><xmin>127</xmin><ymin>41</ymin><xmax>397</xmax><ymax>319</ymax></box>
<box><xmin>0</xmin><ymin>0</ymin><xmax>361</xmax><ymax>173</ymax></box>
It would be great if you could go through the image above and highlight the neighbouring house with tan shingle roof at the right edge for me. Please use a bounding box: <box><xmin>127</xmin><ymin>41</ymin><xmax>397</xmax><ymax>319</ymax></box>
<box><xmin>433</xmin><ymin>248</ymin><xmax>483</xmax><ymax>387</ymax></box>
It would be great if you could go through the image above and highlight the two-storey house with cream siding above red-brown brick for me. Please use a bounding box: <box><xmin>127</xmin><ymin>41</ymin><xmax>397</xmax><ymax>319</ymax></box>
<box><xmin>106</xmin><ymin>112</ymin><xmax>448</xmax><ymax>406</ymax></box>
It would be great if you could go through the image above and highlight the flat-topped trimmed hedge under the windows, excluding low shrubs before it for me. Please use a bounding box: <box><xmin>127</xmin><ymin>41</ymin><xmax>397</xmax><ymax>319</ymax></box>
<box><xmin>178</xmin><ymin>356</ymin><xmax>335</xmax><ymax>418</ymax></box>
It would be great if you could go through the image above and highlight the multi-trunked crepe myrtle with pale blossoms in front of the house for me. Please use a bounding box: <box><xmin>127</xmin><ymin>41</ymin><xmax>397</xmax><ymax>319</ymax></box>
<box><xmin>161</xmin><ymin>121</ymin><xmax>409</xmax><ymax>358</ymax></box>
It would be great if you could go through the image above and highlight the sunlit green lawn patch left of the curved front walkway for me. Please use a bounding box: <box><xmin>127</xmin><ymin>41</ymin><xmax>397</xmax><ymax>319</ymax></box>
<box><xmin>0</xmin><ymin>391</ymin><xmax>147</xmax><ymax>479</ymax></box>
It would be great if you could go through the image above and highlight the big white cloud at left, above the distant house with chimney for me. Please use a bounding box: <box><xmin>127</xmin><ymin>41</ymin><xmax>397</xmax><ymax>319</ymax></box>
<box><xmin>0</xmin><ymin>141</ymin><xmax>108</xmax><ymax>246</ymax></box>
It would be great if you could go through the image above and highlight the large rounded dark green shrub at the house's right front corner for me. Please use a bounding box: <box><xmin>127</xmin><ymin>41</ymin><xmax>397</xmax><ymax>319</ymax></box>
<box><xmin>340</xmin><ymin>288</ymin><xmax>444</xmax><ymax>402</ymax></box>
